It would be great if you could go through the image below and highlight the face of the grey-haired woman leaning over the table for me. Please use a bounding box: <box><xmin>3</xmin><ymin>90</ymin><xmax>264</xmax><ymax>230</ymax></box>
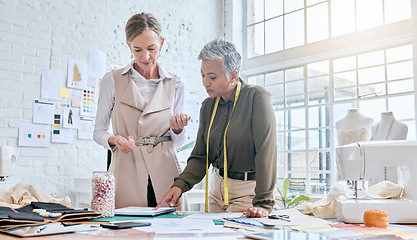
<box><xmin>201</xmin><ymin>60</ymin><xmax>236</xmax><ymax>100</ymax></box>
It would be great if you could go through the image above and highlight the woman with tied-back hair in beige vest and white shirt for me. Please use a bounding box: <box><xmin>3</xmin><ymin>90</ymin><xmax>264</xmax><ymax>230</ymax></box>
<box><xmin>94</xmin><ymin>13</ymin><xmax>190</xmax><ymax>208</ymax></box>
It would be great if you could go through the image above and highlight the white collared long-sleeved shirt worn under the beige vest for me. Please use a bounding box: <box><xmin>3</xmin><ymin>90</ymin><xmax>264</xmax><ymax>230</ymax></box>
<box><xmin>93</xmin><ymin>60</ymin><xmax>185</xmax><ymax>150</ymax></box>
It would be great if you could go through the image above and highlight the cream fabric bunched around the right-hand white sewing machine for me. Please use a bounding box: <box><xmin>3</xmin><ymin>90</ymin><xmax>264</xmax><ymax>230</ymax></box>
<box><xmin>298</xmin><ymin>181</ymin><xmax>404</xmax><ymax>219</ymax></box>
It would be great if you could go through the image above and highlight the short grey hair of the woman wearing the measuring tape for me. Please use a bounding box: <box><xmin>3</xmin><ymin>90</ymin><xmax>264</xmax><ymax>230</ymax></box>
<box><xmin>198</xmin><ymin>38</ymin><xmax>242</xmax><ymax>77</ymax></box>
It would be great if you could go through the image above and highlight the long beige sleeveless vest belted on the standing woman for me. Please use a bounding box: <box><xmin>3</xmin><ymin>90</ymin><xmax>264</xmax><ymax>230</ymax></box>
<box><xmin>109</xmin><ymin>69</ymin><xmax>180</xmax><ymax>208</ymax></box>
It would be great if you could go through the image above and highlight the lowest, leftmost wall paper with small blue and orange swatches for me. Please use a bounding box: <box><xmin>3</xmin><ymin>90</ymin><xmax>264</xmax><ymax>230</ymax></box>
<box><xmin>19</xmin><ymin>123</ymin><xmax>51</xmax><ymax>147</ymax></box>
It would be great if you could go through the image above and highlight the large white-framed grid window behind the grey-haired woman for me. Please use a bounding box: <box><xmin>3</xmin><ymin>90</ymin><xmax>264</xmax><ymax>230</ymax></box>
<box><xmin>242</xmin><ymin>0</ymin><xmax>416</xmax><ymax>194</ymax></box>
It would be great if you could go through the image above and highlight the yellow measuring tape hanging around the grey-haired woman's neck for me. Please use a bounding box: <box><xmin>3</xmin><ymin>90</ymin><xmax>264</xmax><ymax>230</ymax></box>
<box><xmin>205</xmin><ymin>81</ymin><xmax>242</xmax><ymax>212</ymax></box>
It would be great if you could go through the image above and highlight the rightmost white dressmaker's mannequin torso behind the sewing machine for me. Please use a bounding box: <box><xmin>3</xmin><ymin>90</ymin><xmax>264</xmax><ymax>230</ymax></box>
<box><xmin>371</xmin><ymin>112</ymin><xmax>408</xmax><ymax>141</ymax></box>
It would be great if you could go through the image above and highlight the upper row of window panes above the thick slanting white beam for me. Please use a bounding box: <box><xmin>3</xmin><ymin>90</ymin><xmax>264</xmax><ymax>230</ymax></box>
<box><xmin>246</xmin><ymin>0</ymin><xmax>411</xmax><ymax>58</ymax></box>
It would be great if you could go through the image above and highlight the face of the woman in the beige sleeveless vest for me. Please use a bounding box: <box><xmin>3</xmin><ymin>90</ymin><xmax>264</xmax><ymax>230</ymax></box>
<box><xmin>127</xmin><ymin>29</ymin><xmax>164</xmax><ymax>72</ymax></box>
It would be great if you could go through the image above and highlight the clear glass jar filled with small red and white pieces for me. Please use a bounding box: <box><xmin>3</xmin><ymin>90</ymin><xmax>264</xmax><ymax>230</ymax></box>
<box><xmin>91</xmin><ymin>171</ymin><xmax>116</xmax><ymax>218</ymax></box>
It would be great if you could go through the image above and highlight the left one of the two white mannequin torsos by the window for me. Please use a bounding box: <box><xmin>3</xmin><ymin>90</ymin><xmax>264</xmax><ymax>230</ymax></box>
<box><xmin>336</xmin><ymin>108</ymin><xmax>374</xmax><ymax>146</ymax></box>
